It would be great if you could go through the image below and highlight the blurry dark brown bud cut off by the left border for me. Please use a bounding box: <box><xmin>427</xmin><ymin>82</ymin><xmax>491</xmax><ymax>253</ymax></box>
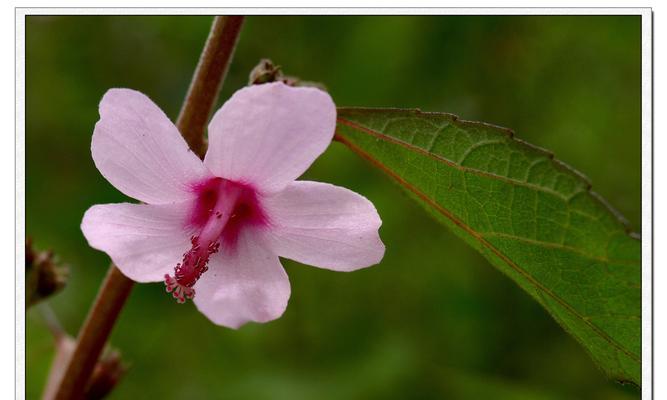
<box><xmin>25</xmin><ymin>238</ymin><xmax>69</xmax><ymax>307</ymax></box>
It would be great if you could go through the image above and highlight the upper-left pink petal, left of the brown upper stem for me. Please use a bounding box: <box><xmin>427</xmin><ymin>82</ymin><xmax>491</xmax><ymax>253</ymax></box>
<box><xmin>91</xmin><ymin>89</ymin><xmax>209</xmax><ymax>204</ymax></box>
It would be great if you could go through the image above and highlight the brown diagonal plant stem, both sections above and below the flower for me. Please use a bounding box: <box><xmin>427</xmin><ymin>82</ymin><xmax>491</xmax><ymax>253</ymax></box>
<box><xmin>45</xmin><ymin>16</ymin><xmax>244</xmax><ymax>400</ymax></box>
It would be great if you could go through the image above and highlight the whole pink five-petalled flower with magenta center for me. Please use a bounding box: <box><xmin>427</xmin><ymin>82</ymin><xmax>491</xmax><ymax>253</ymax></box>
<box><xmin>81</xmin><ymin>83</ymin><xmax>384</xmax><ymax>328</ymax></box>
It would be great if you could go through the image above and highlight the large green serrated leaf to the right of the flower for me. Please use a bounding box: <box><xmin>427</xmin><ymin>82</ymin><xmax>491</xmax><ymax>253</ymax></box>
<box><xmin>335</xmin><ymin>108</ymin><xmax>641</xmax><ymax>385</ymax></box>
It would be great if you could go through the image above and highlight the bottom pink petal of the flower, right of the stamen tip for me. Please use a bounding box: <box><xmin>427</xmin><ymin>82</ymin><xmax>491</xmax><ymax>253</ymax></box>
<box><xmin>193</xmin><ymin>231</ymin><xmax>290</xmax><ymax>329</ymax></box>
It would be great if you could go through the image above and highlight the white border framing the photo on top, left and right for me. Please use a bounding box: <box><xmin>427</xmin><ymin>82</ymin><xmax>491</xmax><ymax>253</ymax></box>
<box><xmin>14</xmin><ymin>7</ymin><xmax>659</xmax><ymax>399</ymax></box>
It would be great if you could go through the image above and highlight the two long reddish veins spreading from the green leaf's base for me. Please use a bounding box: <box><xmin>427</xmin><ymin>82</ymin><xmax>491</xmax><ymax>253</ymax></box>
<box><xmin>334</xmin><ymin>117</ymin><xmax>640</xmax><ymax>363</ymax></box>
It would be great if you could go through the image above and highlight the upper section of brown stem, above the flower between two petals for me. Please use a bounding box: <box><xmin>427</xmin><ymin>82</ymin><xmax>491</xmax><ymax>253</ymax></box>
<box><xmin>176</xmin><ymin>16</ymin><xmax>244</xmax><ymax>157</ymax></box>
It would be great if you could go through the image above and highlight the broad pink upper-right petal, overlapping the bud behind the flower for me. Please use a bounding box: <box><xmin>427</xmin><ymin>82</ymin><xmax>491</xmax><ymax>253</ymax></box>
<box><xmin>204</xmin><ymin>83</ymin><xmax>336</xmax><ymax>193</ymax></box>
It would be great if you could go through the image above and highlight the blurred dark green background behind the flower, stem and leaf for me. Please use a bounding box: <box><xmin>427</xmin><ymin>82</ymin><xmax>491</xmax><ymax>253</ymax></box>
<box><xmin>26</xmin><ymin>16</ymin><xmax>641</xmax><ymax>399</ymax></box>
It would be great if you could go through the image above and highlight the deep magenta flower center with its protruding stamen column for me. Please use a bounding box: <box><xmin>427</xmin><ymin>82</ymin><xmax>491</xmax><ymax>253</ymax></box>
<box><xmin>164</xmin><ymin>178</ymin><xmax>268</xmax><ymax>303</ymax></box>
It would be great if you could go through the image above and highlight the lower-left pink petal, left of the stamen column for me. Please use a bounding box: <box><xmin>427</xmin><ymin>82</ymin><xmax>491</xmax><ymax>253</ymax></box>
<box><xmin>81</xmin><ymin>203</ymin><xmax>191</xmax><ymax>282</ymax></box>
